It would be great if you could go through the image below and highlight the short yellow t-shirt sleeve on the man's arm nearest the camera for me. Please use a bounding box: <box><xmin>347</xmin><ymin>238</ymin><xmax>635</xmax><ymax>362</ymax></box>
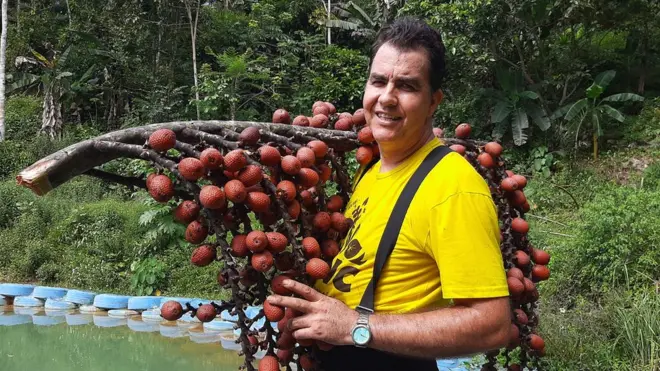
<box><xmin>426</xmin><ymin>192</ymin><xmax>509</xmax><ymax>299</ymax></box>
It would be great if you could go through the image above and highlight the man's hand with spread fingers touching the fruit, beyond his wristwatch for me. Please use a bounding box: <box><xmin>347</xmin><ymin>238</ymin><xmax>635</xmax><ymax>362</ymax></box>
<box><xmin>267</xmin><ymin>279</ymin><xmax>358</xmax><ymax>345</ymax></box>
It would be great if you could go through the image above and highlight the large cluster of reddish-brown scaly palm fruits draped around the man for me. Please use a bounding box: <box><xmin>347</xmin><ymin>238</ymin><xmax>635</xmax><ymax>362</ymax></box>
<box><xmin>137</xmin><ymin>101</ymin><xmax>550</xmax><ymax>371</ymax></box>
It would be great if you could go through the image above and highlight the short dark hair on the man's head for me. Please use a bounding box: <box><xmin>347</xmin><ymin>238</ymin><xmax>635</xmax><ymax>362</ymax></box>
<box><xmin>369</xmin><ymin>17</ymin><xmax>447</xmax><ymax>92</ymax></box>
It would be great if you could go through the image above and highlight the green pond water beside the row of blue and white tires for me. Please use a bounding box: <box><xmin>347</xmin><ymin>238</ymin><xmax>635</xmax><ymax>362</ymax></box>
<box><xmin>0</xmin><ymin>306</ymin><xmax>248</xmax><ymax>371</ymax></box>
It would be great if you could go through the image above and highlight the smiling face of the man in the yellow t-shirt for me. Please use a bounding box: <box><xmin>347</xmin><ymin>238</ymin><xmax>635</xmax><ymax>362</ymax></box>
<box><xmin>362</xmin><ymin>43</ymin><xmax>442</xmax><ymax>150</ymax></box>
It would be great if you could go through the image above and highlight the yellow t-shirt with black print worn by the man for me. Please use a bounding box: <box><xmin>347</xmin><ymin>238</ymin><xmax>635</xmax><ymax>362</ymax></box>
<box><xmin>315</xmin><ymin>138</ymin><xmax>509</xmax><ymax>313</ymax></box>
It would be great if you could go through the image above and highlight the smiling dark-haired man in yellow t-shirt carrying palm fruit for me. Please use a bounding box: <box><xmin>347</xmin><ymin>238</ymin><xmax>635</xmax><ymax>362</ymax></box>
<box><xmin>268</xmin><ymin>18</ymin><xmax>511</xmax><ymax>371</ymax></box>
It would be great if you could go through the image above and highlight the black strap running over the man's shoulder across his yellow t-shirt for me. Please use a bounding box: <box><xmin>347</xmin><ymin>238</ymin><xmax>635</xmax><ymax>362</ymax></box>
<box><xmin>358</xmin><ymin>145</ymin><xmax>452</xmax><ymax>312</ymax></box>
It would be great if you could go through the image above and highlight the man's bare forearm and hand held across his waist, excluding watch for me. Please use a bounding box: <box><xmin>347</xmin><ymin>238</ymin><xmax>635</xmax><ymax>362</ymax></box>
<box><xmin>268</xmin><ymin>280</ymin><xmax>511</xmax><ymax>358</ymax></box>
